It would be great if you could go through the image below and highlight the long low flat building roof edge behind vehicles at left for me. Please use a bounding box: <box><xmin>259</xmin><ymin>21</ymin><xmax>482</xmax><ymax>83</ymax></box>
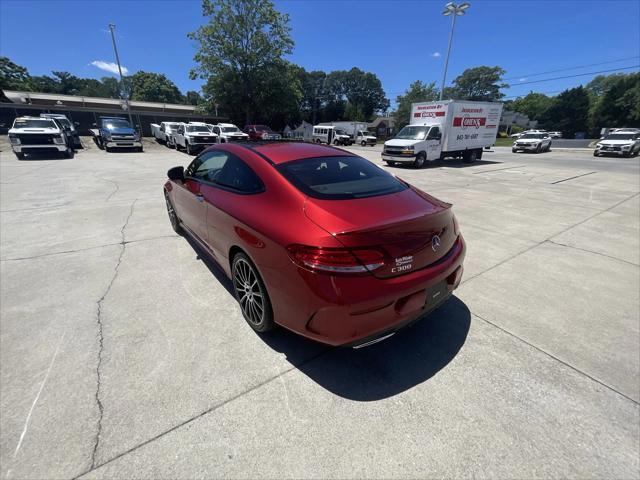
<box><xmin>3</xmin><ymin>90</ymin><xmax>196</xmax><ymax>115</ymax></box>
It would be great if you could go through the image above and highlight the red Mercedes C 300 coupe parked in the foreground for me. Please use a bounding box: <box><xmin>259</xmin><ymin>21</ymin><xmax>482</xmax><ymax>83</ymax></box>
<box><xmin>164</xmin><ymin>143</ymin><xmax>465</xmax><ymax>347</ymax></box>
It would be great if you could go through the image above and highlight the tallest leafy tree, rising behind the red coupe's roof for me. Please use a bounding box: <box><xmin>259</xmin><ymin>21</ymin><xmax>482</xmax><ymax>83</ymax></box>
<box><xmin>188</xmin><ymin>0</ymin><xmax>293</xmax><ymax>123</ymax></box>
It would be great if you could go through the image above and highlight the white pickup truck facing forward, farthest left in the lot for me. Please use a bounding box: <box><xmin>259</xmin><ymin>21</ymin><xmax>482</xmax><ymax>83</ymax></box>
<box><xmin>9</xmin><ymin>117</ymin><xmax>74</xmax><ymax>160</ymax></box>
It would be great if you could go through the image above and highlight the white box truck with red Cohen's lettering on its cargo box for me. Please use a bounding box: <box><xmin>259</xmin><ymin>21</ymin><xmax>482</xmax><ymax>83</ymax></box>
<box><xmin>382</xmin><ymin>100</ymin><xmax>502</xmax><ymax>168</ymax></box>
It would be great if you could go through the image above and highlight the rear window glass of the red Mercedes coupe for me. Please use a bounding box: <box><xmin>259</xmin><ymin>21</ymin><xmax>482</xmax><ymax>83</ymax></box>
<box><xmin>277</xmin><ymin>156</ymin><xmax>407</xmax><ymax>200</ymax></box>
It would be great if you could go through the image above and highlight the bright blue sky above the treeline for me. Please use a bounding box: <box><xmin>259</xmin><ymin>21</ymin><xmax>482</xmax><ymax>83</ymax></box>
<box><xmin>0</xmin><ymin>0</ymin><xmax>640</xmax><ymax>107</ymax></box>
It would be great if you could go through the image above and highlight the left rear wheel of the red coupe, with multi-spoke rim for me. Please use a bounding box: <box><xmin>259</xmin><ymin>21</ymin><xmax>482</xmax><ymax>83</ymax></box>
<box><xmin>231</xmin><ymin>252</ymin><xmax>276</xmax><ymax>333</ymax></box>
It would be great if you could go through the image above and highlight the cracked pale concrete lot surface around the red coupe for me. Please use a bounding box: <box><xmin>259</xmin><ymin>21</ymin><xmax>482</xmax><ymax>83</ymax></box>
<box><xmin>0</xmin><ymin>139</ymin><xmax>640</xmax><ymax>478</ymax></box>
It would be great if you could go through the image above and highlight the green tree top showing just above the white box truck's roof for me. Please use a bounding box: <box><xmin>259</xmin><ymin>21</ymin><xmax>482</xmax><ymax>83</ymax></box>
<box><xmin>445</xmin><ymin>66</ymin><xmax>509</xmax><ymax>102</ymax></box>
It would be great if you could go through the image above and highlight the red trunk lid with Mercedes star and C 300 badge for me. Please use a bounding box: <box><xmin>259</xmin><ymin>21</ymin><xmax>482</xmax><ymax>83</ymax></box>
<box><xmin>305</xmin><ymin>188</ymin><xmax>456</xmax><ymax>278</ymax></box>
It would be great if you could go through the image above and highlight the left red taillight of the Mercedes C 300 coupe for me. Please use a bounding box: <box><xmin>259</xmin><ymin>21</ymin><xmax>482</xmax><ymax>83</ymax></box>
<box><xmin>287</xmin><ymin>245</ymin><xmax>385</xmax><ymax>274</ymax></box>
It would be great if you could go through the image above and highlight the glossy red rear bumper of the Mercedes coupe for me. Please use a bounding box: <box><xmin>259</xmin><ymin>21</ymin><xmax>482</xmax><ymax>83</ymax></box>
<box><xmin>267</xmin><ymin>236</ymin><xmax>466</xmax><ymax>346</ymax></box>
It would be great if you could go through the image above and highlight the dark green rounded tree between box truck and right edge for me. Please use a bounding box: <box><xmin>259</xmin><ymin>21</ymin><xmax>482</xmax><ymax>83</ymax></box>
<box><xmin>540</xmin><ymin>86</ymin><xmax>589</xmax><ymax>138</ymax></box>
